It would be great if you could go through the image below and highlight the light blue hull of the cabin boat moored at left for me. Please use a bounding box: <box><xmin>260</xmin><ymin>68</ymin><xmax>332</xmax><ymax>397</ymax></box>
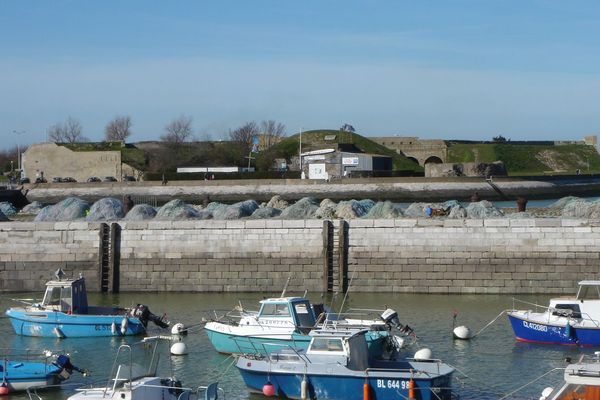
<box><xmin>6</xmin><ymin>309</ymin><xmax>146</xmax><ymax>338</ymax></box>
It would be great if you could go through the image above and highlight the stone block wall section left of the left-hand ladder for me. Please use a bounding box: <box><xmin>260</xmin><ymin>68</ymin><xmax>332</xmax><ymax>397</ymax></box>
<box><xmin>0</xmin><ymin>222</ymin><xmax>100</xmax><ymax>292</ymax></box>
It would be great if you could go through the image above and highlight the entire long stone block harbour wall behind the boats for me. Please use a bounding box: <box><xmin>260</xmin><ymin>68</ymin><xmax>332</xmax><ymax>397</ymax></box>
<box><xmin>0</xmin><ymin>219</ymin><xmax>600</xmax><ymax>293</ymax></box>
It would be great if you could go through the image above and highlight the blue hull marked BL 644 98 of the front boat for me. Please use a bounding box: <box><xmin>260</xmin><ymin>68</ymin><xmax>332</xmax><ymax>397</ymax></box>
<box><xmin>238</xmin><ymin>367</ymin><xmax>451</xmax><ymax>400</ymax></box>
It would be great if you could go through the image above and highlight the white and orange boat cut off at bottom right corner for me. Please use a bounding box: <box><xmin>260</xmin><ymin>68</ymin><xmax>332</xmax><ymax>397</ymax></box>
<box><xmin>540</xmin><ymin>351</ymin><xmax>600</xmax><ymax>400</ymax></box>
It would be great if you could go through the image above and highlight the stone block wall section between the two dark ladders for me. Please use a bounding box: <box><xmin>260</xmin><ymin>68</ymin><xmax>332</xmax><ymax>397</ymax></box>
<box><xmin>120</xmin><ymin>220</ymin><xmax>324</xmax><ymax>293</ymax></box>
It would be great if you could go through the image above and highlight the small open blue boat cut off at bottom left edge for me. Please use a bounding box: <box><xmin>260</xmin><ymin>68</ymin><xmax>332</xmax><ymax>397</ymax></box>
<box><xmin>0</xmin><ymin>349</ymin><xmax>86</xmax><ymax>394</ymax></box>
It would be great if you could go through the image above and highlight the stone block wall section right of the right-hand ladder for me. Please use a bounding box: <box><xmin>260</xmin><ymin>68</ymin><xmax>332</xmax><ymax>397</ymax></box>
<box><xmin>348</xmin><ymin>218</ymin><xmax>600</xmax><ymax>294</ymax></box>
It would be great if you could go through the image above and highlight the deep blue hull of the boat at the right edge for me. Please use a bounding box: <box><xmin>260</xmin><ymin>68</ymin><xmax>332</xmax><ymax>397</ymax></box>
<box><xmin>508</xmin><ymin>312</ymin><xmax>600</xmax><ymax>346</ymax></box>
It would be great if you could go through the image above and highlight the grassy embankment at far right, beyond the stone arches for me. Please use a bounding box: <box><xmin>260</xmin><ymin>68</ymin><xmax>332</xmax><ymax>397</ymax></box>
<box><xmin>448</xmin><ymin>143</ymin><xmax>600</xmax><ymax>176</ymax></box>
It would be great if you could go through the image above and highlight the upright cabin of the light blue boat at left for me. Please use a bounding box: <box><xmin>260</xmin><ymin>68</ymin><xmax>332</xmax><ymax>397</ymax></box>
<box><xmin>41</xmin><ymin>277</ymin><xmax>88</xmax><ymax>314</ymax></box>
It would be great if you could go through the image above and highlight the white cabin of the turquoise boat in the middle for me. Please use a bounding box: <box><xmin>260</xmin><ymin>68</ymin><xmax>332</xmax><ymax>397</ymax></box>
<box><xmin>258</xmin><ymin>297</ymin><xmax>316</xmax><ymax>328</ymax></box>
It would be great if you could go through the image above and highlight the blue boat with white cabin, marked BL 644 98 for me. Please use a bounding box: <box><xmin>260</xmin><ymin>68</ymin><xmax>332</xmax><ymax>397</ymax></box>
<box><xmin>236</xmin><ymin>329</ymin><xmax>454</xmax><ymax>400</ymax></box>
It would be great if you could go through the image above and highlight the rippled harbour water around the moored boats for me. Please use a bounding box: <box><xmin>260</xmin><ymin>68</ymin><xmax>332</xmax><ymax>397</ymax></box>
<box><xmin>0</xmin><ymin>292</ymin><xmax>595</xmax><ymax>400</ymax></box>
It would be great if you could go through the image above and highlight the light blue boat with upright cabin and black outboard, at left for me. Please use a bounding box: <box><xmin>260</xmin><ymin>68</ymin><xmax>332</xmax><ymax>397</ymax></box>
<box><xmin>6</xmin><ymin>269</ymin><xmax>169</xmax><ymax>338</ymax></box>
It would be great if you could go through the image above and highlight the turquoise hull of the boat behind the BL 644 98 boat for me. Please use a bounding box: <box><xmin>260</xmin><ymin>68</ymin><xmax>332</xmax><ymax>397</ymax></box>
<box><xmin>204</xmin><ymin>322</ymin><xmax>389</xmax><ymax>357</ymax></box>
